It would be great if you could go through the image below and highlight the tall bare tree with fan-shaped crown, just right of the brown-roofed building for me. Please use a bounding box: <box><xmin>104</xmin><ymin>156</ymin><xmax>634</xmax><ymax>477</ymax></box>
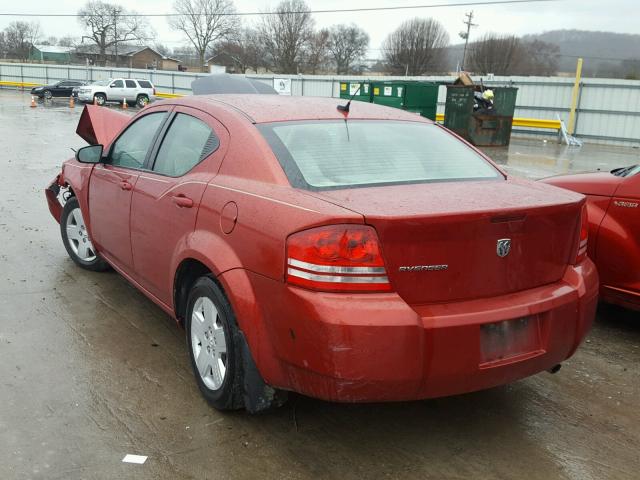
<box><xmin>169</xmin><ymin>0</ymin><xmax>240</xmax><ymax>71</ymax></box>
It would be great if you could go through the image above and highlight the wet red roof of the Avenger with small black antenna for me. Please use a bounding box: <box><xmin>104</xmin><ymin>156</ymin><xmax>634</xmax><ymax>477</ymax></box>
<box><xmin>176</xmin><ymin>94</ymin><xmax>433</xmax><ymax>123</ymax></box>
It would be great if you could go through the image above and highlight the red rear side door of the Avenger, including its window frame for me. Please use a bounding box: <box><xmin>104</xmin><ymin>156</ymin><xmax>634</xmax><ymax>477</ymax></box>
<box><xmin>131</xmin><ymin>107</ymin><xmax>228</xmax><ymax>305</ymax></box>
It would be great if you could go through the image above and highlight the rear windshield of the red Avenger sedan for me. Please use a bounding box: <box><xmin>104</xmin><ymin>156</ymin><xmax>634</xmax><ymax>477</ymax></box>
<box><xmin>258</xmin><ymin>120</ymin><xmax>503</xmax><ymax>189</ymax></box>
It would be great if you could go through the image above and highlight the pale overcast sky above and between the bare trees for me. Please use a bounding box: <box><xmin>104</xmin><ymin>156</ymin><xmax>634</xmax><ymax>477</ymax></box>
<box><xmin>0</xmin><ymin>0</ymin><xmax>640</xmax><ymax>57</ymax></box>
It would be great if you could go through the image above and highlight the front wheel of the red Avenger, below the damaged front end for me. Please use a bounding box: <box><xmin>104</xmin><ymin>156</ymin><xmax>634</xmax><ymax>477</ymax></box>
<box><xmin>60</xmin><ymin>197</ymin><xmax>109</xmax><ymax>272</ymax></box>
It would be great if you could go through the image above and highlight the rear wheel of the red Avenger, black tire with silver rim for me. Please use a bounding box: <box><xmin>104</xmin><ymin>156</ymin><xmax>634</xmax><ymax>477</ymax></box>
<box><xmin>185</xmin><ymin>276</ymin><xmax>244</xmax><ymax>410</ymax></box>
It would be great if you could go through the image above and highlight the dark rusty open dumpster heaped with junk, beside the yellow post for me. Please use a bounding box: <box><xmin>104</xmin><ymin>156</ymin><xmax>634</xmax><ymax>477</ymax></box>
<box><xmin>444</xmin><ymin>85</ymin><xmax>518</xmax><ymax>147</ymax></box>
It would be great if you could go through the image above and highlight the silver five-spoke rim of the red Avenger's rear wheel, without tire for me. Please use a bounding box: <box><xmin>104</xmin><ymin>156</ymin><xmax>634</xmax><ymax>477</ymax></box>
<box><xmin>190</xmin><ymin>297</ymin><xmax>227</xmax><ymax>390</ymax></box>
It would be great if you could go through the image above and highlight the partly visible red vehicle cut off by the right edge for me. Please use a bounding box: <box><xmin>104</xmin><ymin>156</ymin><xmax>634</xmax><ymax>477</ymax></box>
<box><xmin>543</xmin><ymin>165</ymin><xmax>640</xmax><ymax>310</ymax></box>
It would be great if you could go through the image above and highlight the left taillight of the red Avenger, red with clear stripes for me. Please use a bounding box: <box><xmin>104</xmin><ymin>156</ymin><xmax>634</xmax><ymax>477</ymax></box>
<box><xmin>286</xmin><ymin>225</ymin><xmax>391</xmax><ymax>292</ymax></box>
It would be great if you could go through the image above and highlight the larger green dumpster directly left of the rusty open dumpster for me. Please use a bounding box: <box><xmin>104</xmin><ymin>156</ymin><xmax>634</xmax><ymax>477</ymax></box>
<box><xmin>371</xmin><ymin>80</ymin><xmax>440</xmax><ymax>120</ymax></box>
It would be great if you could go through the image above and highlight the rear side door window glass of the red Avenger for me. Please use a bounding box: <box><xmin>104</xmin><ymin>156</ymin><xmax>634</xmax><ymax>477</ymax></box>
<box><xmin>153</xmin><ymin>113</ymin><xmax>220</xmax><ymax>177</ymax></box>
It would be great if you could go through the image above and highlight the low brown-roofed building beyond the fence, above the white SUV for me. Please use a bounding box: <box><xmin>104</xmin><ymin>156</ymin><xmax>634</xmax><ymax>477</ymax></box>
<box><xmin>75</xmin><ymin>45</ymin><xmax>180</xmax><ymax>71</ymax></box>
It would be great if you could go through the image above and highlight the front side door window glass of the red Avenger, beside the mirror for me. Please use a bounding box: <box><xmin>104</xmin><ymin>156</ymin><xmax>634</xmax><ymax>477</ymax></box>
<box><xmin>109</xmin><ymin>112</ymin><xmax>167</xmax><ymax>168</ymax></box>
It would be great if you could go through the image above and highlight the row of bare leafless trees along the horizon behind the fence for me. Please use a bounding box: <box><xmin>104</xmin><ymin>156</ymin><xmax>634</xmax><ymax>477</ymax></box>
<box><xmin>6</xmin><ymin>0</ymin><xmax>637</xmax><ymax>76</ymax></box>
